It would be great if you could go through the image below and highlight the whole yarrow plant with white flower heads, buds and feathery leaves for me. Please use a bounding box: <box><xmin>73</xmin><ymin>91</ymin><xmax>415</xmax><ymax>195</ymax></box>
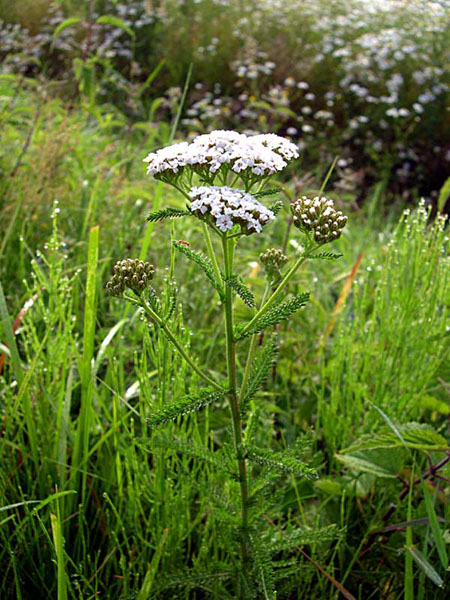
<box><xmin>107</xmin><ymin>131</ymin><xmax>347</xmax><ymax>598</ymax></box>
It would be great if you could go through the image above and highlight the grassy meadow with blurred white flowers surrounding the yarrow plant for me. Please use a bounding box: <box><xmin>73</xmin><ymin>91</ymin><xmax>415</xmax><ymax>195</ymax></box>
<box><xmin>0</xmin><ymin>0</ymin><xmax>450</xmax><ymax>600</ymax></box>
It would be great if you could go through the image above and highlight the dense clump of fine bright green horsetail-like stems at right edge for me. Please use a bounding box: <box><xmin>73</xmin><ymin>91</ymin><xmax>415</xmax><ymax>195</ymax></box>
<box><xmin>316</xmin><ymin>205</ymin><xmax>450</xmax><ymax>454</ymax></box>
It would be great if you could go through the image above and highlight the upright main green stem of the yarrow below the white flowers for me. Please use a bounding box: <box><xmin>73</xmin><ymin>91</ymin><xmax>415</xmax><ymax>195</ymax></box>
<box><xmin>222</xmin><ymin>235</ymin><xmax>250</xmax><ymax>573</ymax></box>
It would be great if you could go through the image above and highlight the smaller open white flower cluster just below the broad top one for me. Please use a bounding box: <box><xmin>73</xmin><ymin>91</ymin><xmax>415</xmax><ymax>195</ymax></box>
<box><xmin>189</xmin><ymin>186</ymin><xmax>275</xmax><ymax>234</ymax></box>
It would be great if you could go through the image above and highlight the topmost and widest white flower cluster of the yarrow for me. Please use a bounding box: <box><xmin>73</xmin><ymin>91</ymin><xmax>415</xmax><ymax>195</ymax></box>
<box><xmin>144</xmin><ymin>130</ymin><xmax>298</xmax><ymax>180</ymax></box>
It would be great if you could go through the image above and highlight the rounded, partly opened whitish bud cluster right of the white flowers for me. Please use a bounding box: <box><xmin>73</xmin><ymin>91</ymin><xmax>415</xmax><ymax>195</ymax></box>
<box><xmin>291</xmin><ymin>196</ymin><xmax>347</xmax><ymax>244</ymax></box>
